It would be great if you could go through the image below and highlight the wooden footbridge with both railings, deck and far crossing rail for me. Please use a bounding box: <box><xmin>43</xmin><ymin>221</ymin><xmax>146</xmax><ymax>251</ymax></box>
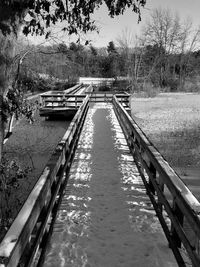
<box><xmin>0</xmin><ymin>86</ymin><xmax>200</xmax><ymax>267</ymax></box>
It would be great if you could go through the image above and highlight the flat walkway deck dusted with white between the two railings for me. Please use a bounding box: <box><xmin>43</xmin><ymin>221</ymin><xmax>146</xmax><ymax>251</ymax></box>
<box><xmin>41</xmin><ymin>103</ymin><xmax>177</xmax><ymax>267</ymax></box>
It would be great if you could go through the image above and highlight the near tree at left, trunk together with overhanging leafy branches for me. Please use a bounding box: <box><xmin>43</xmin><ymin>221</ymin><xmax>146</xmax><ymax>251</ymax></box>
<box><xmin>0</xmin><ymin>0</ymin><xmax>146</xmax><ymax>161</ymax></box>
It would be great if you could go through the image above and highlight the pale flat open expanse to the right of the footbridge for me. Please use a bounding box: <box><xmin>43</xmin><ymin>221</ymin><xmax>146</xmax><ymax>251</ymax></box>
<box><xmin>131</xmin><ymin>93</ymin><xmax>200</xmax><ymax>199</ymax></box>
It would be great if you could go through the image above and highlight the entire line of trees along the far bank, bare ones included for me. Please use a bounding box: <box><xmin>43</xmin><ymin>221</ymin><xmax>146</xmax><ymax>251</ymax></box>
<box><xmin>19</xmin><ymin>9</ymin><xmax>200</xmax><ymax>94</ymax></box>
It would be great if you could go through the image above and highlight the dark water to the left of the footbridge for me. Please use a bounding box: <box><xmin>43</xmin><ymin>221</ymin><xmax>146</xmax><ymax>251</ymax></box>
<box><xmin>4</xmin><ymin>111</ymin><xmax>70</xmax><ymax>220</ymax></box>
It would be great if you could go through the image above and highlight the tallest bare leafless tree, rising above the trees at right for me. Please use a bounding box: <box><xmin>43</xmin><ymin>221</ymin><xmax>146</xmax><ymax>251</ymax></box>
<box><xmin>143</xmin><ymin>8</ymin><xmax>181</xmax><ymax>87</ymax></box>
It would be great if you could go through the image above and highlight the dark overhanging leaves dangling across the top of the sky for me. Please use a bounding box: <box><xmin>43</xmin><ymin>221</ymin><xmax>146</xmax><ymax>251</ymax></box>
<box><xmin>0</xmin><ymin>0</ymin><xmax>146</xmax><ymax>38</ymax></box>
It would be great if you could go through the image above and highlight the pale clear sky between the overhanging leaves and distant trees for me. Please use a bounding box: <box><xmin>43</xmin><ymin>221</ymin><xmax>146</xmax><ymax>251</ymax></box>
<box><xmin>24</xmin><ymin>0</ymin><xmax>200</xmax><ymax>47</ymax></box>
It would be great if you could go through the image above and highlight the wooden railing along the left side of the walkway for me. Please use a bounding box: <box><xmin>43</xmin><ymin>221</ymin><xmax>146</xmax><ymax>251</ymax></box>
<box><xmin>0</xmin><ymin>96</ymin><xmax>89</xmax><ymax>267</ymax></box>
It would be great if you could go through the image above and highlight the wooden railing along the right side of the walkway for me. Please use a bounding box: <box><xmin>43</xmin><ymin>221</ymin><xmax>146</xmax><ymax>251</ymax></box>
<box><xmin>113</xmin><ymin>96</ymin><xmax>200</xmax><ymax>267</ymax></box>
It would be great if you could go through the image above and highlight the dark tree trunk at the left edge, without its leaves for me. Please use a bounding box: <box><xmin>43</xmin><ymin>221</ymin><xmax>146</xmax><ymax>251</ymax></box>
<box><xmin>0</xmin><ymin>3</ymin><xmax>27</xmax><ymax>162</ymax></box>
